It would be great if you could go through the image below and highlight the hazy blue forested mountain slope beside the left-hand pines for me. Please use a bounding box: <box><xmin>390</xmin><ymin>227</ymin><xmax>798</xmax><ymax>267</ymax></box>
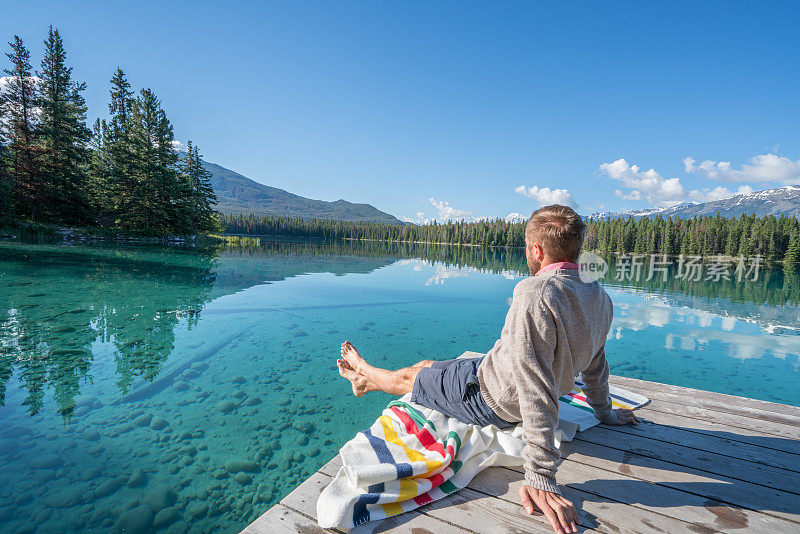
<box><xmin>203</xmin><ymin>161</ymin><xmax>401</xmax><ymax>224</ymax></box>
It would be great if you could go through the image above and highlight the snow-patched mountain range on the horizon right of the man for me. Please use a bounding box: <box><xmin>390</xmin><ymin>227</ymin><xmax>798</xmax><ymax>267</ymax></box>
<box><xmin>589</xmin><ymin>185</ymin><xmax>800</xmax><ymax>219</ymax></box>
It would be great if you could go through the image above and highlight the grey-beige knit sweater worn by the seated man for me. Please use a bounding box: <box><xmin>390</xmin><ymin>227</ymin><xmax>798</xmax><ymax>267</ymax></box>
<box><xmin>478</xmin><ymin>269</ymin><xmax>616</xmax><ymax>493</ymax></box>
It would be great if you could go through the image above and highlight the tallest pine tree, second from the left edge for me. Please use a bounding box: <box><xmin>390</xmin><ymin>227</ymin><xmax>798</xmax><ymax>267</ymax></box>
<box><xmin>39</xmin><ymin>26</ymin><xmax>91</xmax><ymax>223</ymax></box>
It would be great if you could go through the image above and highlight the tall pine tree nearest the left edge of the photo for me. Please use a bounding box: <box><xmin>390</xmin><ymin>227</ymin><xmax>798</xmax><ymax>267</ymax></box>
<box><xmin>0</xmin><ymin>35</ymin><xmax>44</xmax><ymax>220</ymax></box>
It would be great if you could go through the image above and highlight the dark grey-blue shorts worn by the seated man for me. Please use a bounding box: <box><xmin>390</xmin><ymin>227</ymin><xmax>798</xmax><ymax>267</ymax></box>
<box><xmin>411</xmin><ymin>358</ymin><xmax>515</xmax><ymax>428</ymax></box>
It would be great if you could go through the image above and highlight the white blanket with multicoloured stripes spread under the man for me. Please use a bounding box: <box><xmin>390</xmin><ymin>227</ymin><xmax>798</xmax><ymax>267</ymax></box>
<box><xmin>317</xmin><ymin>380</ymin><xmax>648</xmax><ymax>528</ymax></box>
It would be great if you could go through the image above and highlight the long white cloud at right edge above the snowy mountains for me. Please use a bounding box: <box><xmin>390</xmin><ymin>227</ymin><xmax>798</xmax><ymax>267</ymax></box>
<box><xmin>683</xmin><ymin>154</ymin><xmax>800</xmax><ymax>185</ymax></box>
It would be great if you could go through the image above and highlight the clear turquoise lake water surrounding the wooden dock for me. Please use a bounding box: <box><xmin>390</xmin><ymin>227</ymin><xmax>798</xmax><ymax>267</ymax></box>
<box><xmin>0</xmin><ymin>240</ymin><xmax>800</xmax><ymax>533</ymax></box>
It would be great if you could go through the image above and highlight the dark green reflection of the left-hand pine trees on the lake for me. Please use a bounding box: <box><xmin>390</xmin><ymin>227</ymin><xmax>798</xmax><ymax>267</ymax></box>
<box><xmin>0</xmin><ymin>245</ymin><xmax>217</xmax><ymax>417</ymax></box>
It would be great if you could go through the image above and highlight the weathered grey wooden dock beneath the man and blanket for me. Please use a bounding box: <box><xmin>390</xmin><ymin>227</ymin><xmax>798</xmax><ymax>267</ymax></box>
<box><xmin>243</xmin><ymin>376</ymin><xmax>800</xmax><ymax>534</ymax></box>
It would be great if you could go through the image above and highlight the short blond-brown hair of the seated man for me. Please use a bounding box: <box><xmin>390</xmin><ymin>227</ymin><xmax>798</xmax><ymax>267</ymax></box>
<box><xmin>525</xmin><ymin>204</ymin><xmax>586</xmax><ymax>262</ymax></box>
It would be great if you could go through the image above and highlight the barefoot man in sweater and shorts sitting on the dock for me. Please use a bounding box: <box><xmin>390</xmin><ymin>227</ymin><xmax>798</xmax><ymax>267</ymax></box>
<box><xmin>337</xmin><ymin>205</ymin><xmax>639</xmax><ymax>533</ymax></box>
